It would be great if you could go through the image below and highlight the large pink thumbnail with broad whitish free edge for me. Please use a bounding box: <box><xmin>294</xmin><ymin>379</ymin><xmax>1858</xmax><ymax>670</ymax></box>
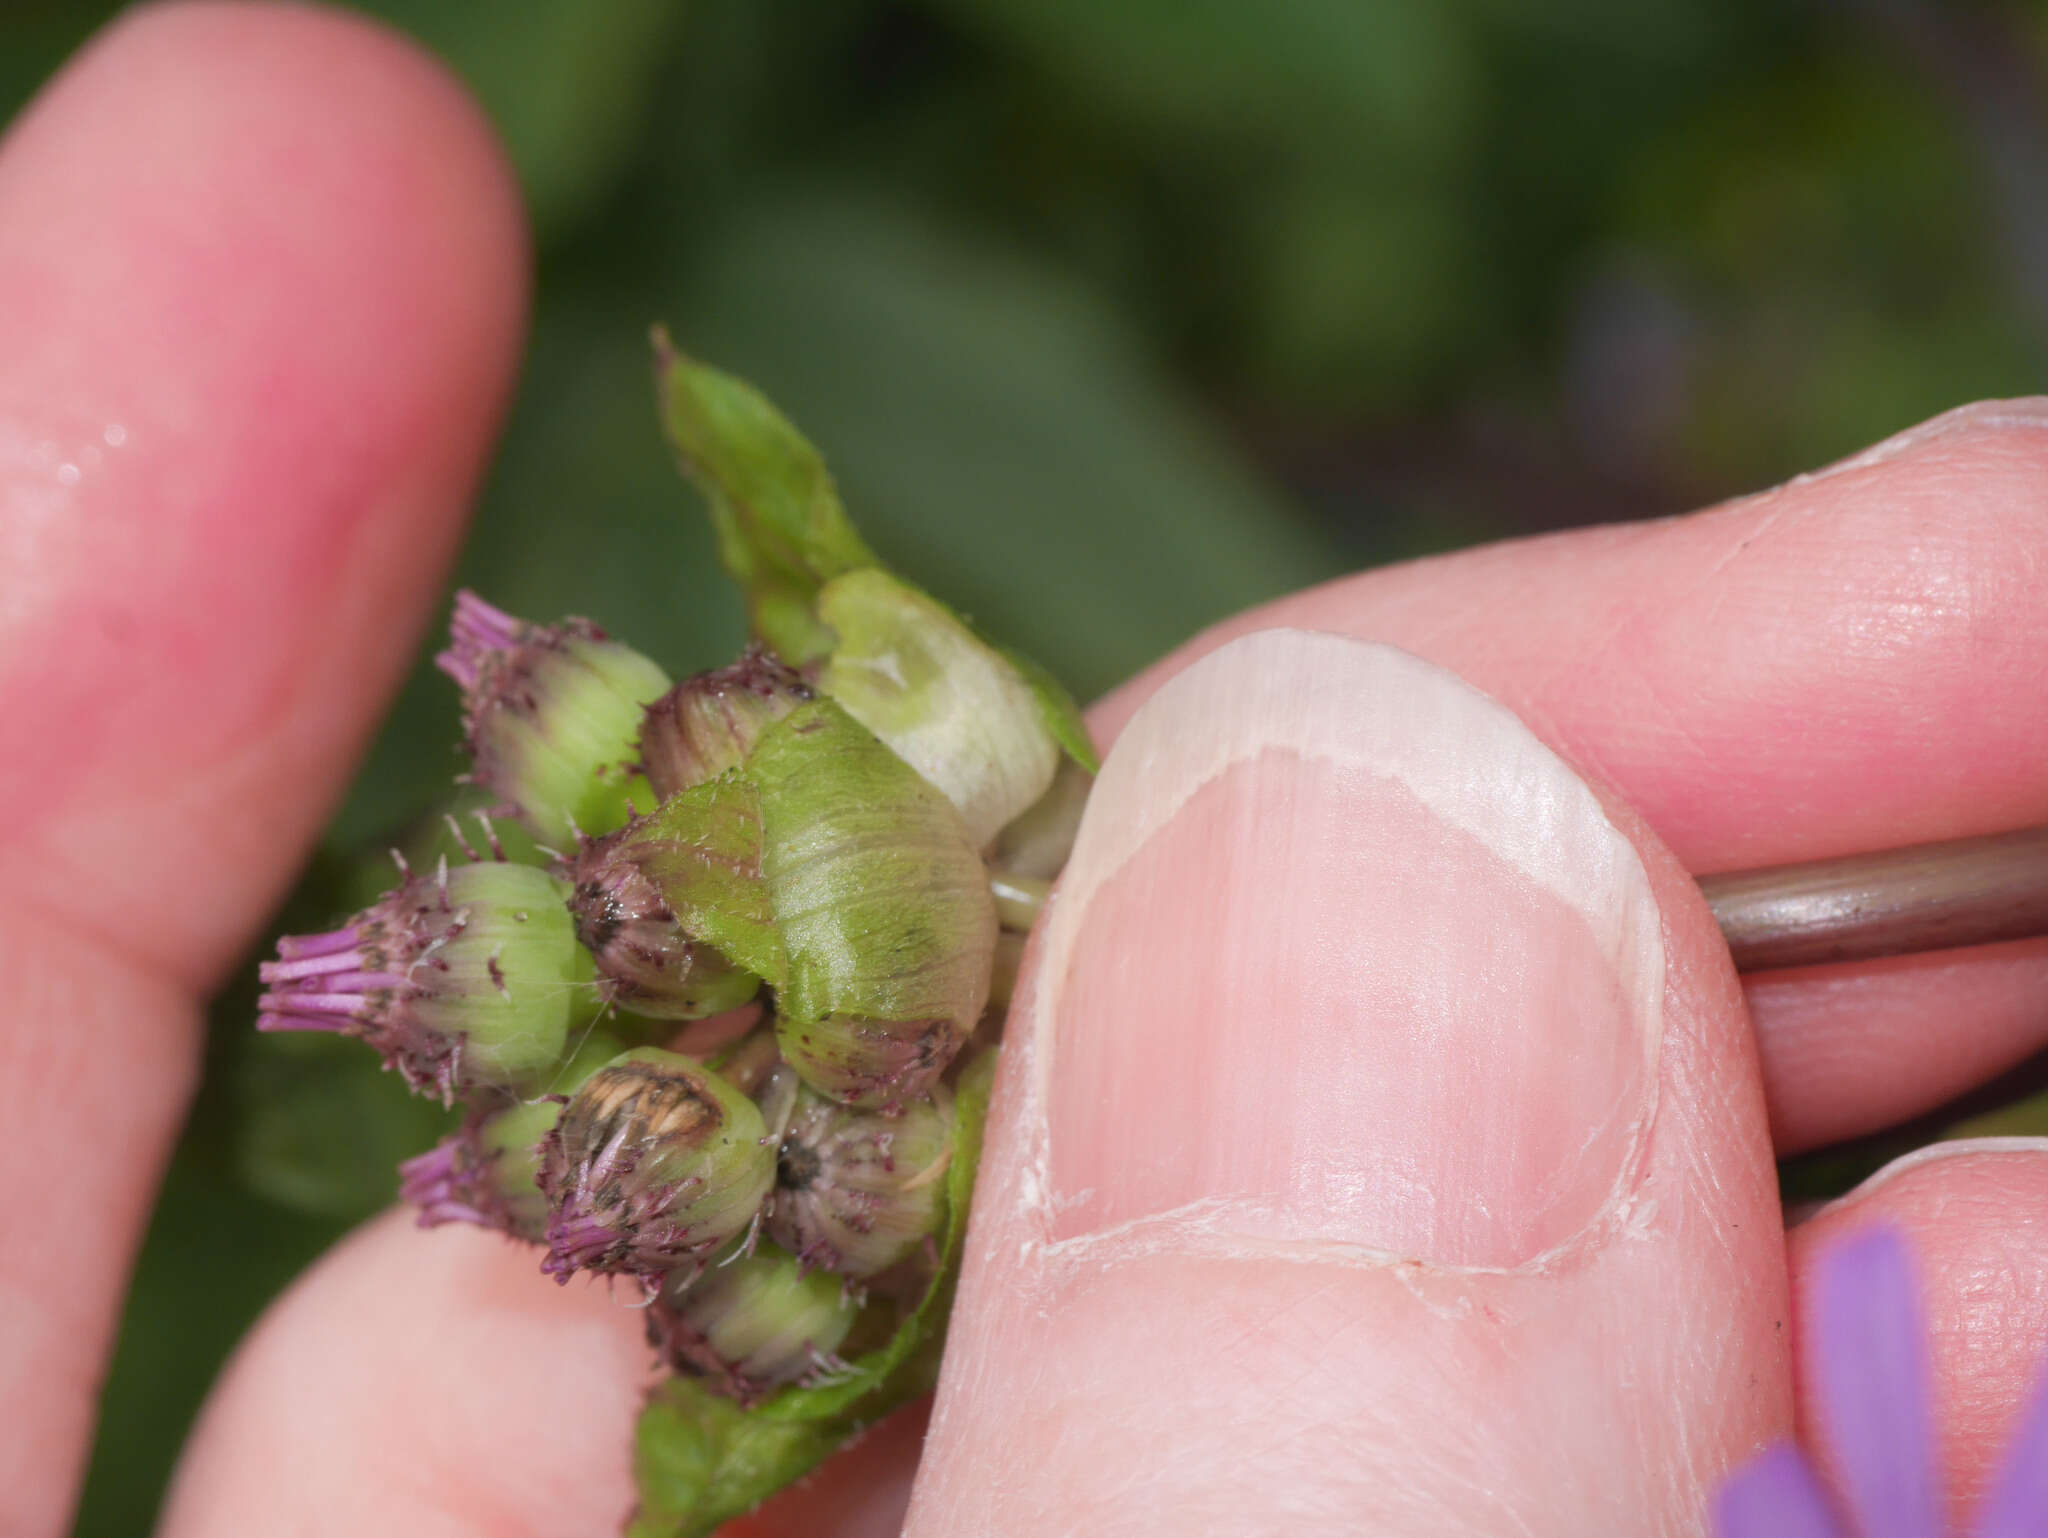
<box><xmin>1030</xmin><ymin>631</ymin><xmax>1665</xmax><ymax>1268</ymax></box>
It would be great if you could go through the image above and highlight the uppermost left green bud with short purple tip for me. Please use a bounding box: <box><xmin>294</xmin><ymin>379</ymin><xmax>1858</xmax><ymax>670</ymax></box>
<box><xmin>434</xmin><ymin>592</ymin><xmax>670</xmax><ymax>848</ymax></box>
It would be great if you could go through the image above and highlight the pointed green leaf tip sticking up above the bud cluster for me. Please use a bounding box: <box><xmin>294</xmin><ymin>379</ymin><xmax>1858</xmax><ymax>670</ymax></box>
<box><xmin>653</xmin><ymin>326</ymin><xmax>879</xmax><ymax>666</ymax></box>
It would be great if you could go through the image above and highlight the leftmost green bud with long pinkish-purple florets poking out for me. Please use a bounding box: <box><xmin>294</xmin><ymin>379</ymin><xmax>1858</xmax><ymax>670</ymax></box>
<box><xmin>256</xmin><ymin>862</ymin><xmax>594</xmax><ymax>1104</ymax></box>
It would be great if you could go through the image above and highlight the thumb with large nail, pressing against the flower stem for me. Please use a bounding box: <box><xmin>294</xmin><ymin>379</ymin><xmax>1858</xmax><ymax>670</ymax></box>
<box><xmin>909</xmin><ymin>631</ymin><xmax>1790</xmax><ymax>1538</ymax></box>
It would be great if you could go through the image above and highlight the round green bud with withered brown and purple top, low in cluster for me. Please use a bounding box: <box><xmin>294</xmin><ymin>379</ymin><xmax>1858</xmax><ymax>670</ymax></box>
<box><xmin>539</xmin><ymin>1046</ymin><xmax>774</xmax><ymax>1282</ymax></box>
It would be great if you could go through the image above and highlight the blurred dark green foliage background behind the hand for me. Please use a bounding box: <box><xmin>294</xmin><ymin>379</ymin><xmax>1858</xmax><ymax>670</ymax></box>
<box><xmin>12</xmin><ymin>0</ymin><xmax>2048</xmax><ymax>1534</ymax></box>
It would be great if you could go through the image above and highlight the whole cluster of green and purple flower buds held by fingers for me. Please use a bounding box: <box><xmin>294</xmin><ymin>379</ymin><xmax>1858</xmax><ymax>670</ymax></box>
<box><xmin>258</xmin><ymin>569</ymin><xmax>1059</xmax><ymax>1403</ymax></box>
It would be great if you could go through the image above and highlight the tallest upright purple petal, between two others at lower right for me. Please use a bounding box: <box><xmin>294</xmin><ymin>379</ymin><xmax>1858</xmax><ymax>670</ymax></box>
<box><xmin>1808</xmin><ymin>1227</ymin><xmax>1942</xmax><ymax>1538</ymax></box>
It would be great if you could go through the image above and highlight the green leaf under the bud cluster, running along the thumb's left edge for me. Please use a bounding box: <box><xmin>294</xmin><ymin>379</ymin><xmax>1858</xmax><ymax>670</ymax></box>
<box><xmin>627</xmin><ymin>1051</ymin><xmax>995</xmax><ymax>1538</ymax></box>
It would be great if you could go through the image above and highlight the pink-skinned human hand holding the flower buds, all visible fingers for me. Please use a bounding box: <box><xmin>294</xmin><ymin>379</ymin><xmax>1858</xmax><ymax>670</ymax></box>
<box><xmin>16</xmin><ymin>6</ymin><xmax>2048</xmax><ymax>1534</ymax></box>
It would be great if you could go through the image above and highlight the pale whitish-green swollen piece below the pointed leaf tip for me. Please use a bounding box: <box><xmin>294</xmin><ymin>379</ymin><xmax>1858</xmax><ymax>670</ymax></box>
<box><xmin>817</xmin><ymin>567</ymin><xmax>1061</xmax><ymax>850</ymax></box>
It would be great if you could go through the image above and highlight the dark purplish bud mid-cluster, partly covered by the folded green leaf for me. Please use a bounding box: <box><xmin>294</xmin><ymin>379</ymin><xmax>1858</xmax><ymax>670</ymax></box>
<box><xmin>569</xmin><ymin>823</ymin><xmax>760</xmax><ymax>1020</ymax></box>
